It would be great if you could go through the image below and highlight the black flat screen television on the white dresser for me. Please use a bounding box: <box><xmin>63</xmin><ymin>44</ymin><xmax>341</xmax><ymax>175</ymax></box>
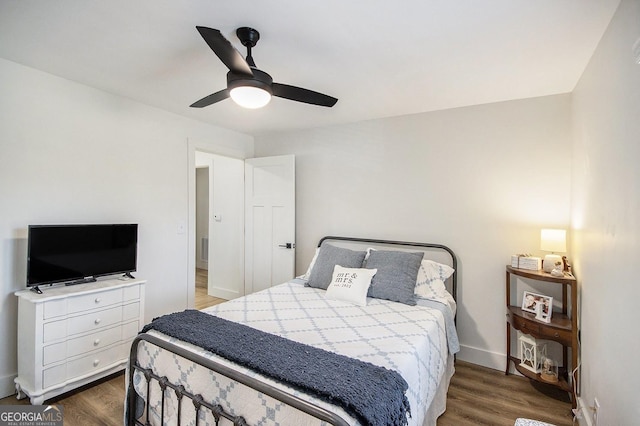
<box><xmin>27</xmin><ymin>224</ymin><xmax>138</xmax><ymax>291</ymax></box>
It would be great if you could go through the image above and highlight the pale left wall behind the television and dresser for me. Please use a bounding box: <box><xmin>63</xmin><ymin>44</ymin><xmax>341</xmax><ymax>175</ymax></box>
<box><xmin>0</xmin><ymin>59</ymin><xmax>253</xmax><ymax>396</ymax></box>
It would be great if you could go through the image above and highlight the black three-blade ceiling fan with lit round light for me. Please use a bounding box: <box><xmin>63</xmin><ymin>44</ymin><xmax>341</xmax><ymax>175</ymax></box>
<box><xmin>191</xmin><ymin>27</ymin><xmax>338</xmax><ymax>108</ymax></box>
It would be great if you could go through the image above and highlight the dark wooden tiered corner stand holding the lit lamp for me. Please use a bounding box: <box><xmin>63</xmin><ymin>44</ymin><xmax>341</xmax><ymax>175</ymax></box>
<box><xmin>505</xmin><ymin>265</ymin><xmax>578</xmax><ymax>408</ymax></box>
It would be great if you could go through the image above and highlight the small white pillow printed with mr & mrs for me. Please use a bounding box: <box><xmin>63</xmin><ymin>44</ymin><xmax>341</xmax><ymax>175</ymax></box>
<box><xmin>325</xmin><ymin>265</ymin><xmax>378</xmax><ymax>306</ymax></box>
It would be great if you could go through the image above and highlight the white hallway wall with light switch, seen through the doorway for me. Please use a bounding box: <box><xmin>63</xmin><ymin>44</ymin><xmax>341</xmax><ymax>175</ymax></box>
<box><xmin>196</xmin><ymin>151</ymin><xmax>244</xmax><ymax>300</ymax></box>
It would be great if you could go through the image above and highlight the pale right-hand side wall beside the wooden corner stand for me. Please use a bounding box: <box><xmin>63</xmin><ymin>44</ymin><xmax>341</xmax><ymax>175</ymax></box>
<box><xmin>572</xmin><ymin>0</ymin><xmax>640</xmax><ymax>425</ymax></box>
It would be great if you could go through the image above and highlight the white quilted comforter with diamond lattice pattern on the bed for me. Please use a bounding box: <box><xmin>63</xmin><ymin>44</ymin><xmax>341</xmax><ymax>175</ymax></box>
<box><xmin>135</xmin><ymin>281</ymin><xmax>455</xmax><ymax>425</ymax></box>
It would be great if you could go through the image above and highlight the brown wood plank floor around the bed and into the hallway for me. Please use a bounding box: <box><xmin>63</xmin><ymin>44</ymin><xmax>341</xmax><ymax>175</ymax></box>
<box><xmin>0</xmin><ymin>271</ymin><xmax>573</xmax><ymax>426</ymax></box>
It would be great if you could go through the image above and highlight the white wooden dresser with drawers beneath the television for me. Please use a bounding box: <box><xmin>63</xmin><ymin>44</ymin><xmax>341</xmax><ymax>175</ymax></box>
<box><xmin>15</xmin><ymin>279</ymin><xmax>146</xmax><ymax>404</ymax></box>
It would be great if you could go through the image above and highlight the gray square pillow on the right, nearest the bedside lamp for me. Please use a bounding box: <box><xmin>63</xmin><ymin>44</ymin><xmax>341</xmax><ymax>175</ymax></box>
<box><xmin>365</xmin><ymin>250</ymin><xmax>424</xmax><ymax>305</ymax></box>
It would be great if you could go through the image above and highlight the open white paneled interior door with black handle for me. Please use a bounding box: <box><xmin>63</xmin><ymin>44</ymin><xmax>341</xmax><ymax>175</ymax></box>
<box><xmin>245</xmin><ymin>155</ymin><xmax>296</xmax><ymax>294</ymax></box>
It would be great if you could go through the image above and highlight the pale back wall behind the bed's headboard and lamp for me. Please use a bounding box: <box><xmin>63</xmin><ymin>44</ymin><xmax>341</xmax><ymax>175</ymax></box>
<box><xmin>255</xmin><ymin>95</ymin><xmax>571</xmax><ymax>370</ymax></box>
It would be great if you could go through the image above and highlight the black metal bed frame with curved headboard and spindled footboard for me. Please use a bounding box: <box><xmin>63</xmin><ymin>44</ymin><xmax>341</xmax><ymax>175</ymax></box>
<box><xmin>125</xmin><ymin>236</ymin><xmax>457</xmax><ymax>426</ymax></box>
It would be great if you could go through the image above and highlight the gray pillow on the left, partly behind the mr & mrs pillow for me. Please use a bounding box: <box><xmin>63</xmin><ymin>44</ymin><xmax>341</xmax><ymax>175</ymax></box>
<box><xmin>307</xmin><ymin>244</ymin><xmax>367</xmax><ymax>290</ymax></box>
